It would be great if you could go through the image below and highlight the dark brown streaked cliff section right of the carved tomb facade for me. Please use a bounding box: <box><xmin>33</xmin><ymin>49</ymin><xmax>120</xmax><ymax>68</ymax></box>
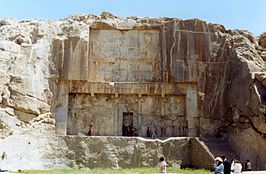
<box><xmin>163</xmin><ymin>20</ymin><xmax>266</xmax><ymax>168</ymax></box>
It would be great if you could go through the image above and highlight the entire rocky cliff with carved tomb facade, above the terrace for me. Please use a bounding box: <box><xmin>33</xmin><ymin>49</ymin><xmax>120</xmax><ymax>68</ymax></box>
<box><xmin>0</xmin><ymin>13</ymin><xmax>266</xmax><ymax>168</ymax></box>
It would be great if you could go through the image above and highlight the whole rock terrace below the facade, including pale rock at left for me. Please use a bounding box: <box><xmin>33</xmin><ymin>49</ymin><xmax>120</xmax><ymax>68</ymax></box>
<box><xmin>0</xmin><ymin>119</ymin><xmax>213</xmax><ymax>170</ymax></box>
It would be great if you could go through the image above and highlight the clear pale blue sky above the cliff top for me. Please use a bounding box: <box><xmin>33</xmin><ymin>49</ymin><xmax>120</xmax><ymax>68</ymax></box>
<box><xmin>0</xmin><ymin>0</ymin><xmax>266</xmax><ymax>36</ymax></box>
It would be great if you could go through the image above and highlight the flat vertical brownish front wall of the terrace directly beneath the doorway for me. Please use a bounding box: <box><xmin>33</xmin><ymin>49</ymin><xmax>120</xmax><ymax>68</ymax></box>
<box><xmin>62</xmin><ymin>137</ymin><xmax>190</xmax><ymax>167</ymax></box>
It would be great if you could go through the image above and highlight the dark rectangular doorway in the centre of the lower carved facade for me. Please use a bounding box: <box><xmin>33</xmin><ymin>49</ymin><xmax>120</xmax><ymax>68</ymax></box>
<box><xmin>122</xmin><ymin>112</ymin><xmax>134</xmax><ymax>136</ymax></box>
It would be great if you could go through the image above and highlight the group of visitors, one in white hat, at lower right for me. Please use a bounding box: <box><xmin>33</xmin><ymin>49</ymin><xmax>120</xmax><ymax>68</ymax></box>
<box><xmin>214</xmin><ymin>155</ymin><xmax>252</xmax><ymax>174</ymax></box>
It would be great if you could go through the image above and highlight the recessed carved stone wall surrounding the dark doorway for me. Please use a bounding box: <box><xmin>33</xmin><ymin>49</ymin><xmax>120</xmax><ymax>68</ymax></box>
<box><xmin>68</xmin><ymin>94</ymin><xmax>187</xmax><ymax>137</ymax></box>
